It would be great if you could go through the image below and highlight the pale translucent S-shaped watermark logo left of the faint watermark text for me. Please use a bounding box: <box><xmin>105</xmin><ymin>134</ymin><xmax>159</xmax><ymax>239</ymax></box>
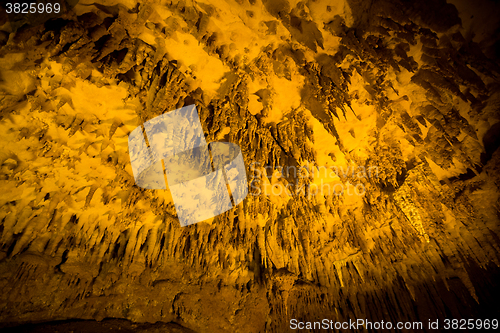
<box><xmin>128</xmin><ymin>105</ymin><xmax>248</xmax><ymax>226</ymax></box>
